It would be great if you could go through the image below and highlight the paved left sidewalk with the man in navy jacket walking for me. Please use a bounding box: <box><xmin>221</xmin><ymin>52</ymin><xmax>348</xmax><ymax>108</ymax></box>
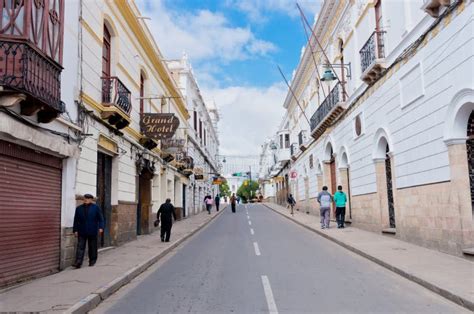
<box><xmin>0</xmin><ymin>206</ymin><xmax>225</xmax><ymax>313</ymax></box>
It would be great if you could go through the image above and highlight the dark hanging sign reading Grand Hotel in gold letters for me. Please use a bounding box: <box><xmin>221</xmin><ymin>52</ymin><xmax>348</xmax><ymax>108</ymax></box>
<box><xmin>140</xmin><ymin>113</ymin><xmax>179</xmax><ymax>140</ymax></box>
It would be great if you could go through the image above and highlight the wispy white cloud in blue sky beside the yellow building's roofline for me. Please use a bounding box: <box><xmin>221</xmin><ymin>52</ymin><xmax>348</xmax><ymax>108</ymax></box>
<box><xmin>139</xmin><ymin>0</ymin><xmax>277</xmax><ymax>62</ymax></box>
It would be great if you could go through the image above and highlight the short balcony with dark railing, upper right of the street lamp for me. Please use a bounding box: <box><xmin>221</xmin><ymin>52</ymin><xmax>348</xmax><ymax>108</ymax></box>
<box><xmin>359</xmin><ymin>31</ymin><xmax>386</xmax><ymax>85</ymax></box>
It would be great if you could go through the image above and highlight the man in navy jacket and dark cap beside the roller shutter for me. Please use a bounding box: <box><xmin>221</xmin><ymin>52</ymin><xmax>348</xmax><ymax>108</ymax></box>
<box><xmin>72</xmin><ymin>194</ymin><xmax>104</xmax><ymax>268</ymax></box>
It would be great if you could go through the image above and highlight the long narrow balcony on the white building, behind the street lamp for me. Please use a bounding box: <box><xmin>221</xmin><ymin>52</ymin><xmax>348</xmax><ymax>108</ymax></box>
<box><xmin>310</xmin><ymin>83</ymin><xmax>347</xmax><ymax>139</ymax></box>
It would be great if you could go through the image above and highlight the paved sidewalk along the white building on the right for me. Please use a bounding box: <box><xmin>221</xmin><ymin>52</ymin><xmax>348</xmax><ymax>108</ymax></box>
<box><xmin>263</xmin><ymin>203</ymin><xmax>474</xmax><ymax>311</ymax></box>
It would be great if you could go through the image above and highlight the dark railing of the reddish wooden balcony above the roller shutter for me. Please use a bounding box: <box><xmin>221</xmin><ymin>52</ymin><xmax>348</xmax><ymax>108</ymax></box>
<box><xmin>0</xmin><ymin>39</ymin><xmax>64</xmax><ymax>113</ymax></box>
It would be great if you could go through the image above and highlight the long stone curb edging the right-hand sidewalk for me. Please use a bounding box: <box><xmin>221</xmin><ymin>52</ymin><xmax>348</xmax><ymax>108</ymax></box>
<box><xmin>263</xmin><ymin>204</ymin><xmax>474</xmax><ymax>311</ymax></box>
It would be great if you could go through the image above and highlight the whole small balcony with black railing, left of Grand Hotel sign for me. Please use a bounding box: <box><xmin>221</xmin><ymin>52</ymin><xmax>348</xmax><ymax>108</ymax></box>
<box><xmin>101</xmin><ymin>76</ymin><xmax>132</xmax><ymax>130</ymax></box>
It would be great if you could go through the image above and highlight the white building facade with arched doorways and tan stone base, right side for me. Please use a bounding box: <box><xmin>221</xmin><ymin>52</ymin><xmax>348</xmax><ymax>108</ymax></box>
<box><xmin>273</xmin><ymin>0</ymin><xmax>474</xmax><ymax>255</ymax></box>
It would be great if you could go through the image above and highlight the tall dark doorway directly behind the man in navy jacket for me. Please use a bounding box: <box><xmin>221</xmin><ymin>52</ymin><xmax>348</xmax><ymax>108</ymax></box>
<box><xmin>96</xmin><ymin>152</ymin><xmax>112</xmax><ymax>247</ymax></box>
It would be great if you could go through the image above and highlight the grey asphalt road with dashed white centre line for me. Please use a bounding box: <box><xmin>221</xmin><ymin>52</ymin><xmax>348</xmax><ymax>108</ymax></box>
<box><xmin>94</xmin><ymin>205</ymin><xmax>467</xmax><ymax>313</ymax></box>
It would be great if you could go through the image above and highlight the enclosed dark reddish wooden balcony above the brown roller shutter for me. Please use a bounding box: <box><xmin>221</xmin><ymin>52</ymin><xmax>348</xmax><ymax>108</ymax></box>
<box><xmin>0</xmin><ymin>0</ymin><xmax>65</xmax><ymax>123</ymax></box>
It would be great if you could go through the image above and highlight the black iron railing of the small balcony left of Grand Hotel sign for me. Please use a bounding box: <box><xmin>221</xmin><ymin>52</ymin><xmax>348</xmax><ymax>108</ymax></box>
<box><xmin>102</xmin><ymin>76</ymin><xmax>132</xmax><ymax>115</ymax></box>
